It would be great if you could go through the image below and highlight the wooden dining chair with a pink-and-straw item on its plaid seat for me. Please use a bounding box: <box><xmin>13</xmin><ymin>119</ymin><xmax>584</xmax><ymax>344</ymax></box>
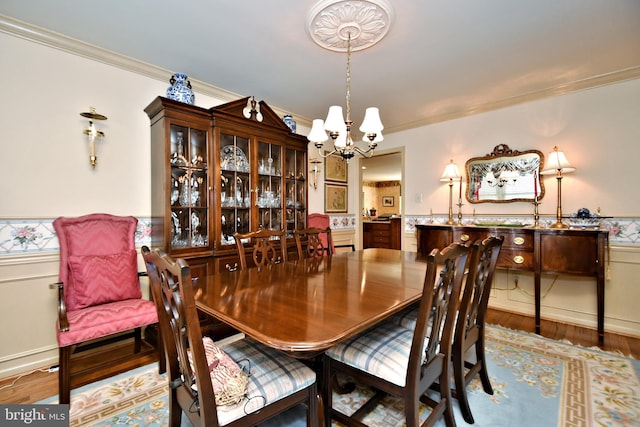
<box><xmin>142</xmin><ymin>246</ymin><xmax>318</xmax><ymax>427</ymax></box>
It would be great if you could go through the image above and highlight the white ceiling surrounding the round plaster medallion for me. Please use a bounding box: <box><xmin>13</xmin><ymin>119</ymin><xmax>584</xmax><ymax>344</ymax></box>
<box><xmin>0</xmin><ymin>0</ymin><xmax>640</xmax><ymax>137</ymax></box>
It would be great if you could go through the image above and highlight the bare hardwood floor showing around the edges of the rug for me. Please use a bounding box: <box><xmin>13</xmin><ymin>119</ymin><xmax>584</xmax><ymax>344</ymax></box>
<box><xmin>0</xmin><ymin>309</ymin><xmax>640</xmax><ymax>403</ymax></box>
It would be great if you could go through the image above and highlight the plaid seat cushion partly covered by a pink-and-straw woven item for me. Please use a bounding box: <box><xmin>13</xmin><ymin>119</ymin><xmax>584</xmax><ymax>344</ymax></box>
<box><xmin>218</xmin><ymin>338</ymin><xmax>316</xmax><ymax>425</ymax></box>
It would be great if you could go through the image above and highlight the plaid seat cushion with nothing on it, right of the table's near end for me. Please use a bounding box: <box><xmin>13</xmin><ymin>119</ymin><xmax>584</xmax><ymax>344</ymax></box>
<box><xmin>326</xmin><ymin>322</ymin><xmax>420</xmax><ymax>387</ymax></box>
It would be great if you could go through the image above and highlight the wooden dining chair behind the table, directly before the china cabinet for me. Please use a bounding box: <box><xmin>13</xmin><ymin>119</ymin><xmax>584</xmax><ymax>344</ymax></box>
<box><xmin>233</xmin><ymin>228</ymin><xmax>287</xmax><ymax>270</ymax></box>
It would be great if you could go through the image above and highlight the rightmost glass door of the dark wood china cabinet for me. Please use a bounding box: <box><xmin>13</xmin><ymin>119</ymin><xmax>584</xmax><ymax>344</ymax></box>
<box><xmin>285</xmin><ymin>149</ymin><xmax>307</xmax><ymax>237</ymax></box>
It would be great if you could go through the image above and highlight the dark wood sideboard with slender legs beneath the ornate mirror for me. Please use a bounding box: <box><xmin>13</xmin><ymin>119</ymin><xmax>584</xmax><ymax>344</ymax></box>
<box><xmin>416</xmin><ymin>225</ymin><xmax>609</xmax><ymax>346</ymax></box>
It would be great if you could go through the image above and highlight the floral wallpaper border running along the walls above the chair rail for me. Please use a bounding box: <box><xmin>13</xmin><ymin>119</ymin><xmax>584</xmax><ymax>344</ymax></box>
<box><xmin>0</xmin><ymin>214</ymin><xmax>640</xmax><ymax>256</ymax></box>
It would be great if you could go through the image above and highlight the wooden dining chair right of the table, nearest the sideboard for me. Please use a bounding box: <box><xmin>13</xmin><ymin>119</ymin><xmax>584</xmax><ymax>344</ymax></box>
<box><xmin>451</xmin><ymin>236</ymin><xmax>504</xmax><ymax>424</ymax></box>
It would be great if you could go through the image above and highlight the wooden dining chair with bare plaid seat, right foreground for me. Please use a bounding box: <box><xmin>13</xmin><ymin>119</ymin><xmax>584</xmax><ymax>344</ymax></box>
<box><xmin>323</xmin><ymin>243</ymin><xmax>470</xmax><ymax>427</ymax></box>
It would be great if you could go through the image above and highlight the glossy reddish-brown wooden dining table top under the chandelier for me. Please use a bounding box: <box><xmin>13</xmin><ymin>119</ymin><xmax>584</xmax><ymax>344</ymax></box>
<box><xmin>194</xmin><ymin>248</ymin><xmax>427</xmax><ymax>358</ymax></box>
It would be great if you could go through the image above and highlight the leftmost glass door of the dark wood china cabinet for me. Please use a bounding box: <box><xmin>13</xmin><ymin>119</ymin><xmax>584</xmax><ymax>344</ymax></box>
<box><xmin>169</xmin><ymin>124</ymin><xmax>209</xmax><ymax>249</ymax></box>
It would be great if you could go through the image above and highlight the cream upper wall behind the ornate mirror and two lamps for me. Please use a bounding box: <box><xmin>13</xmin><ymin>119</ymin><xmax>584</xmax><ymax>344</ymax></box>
<box><xmin>364</xmin><ymin>80</ymin><xmax>640</xmax><ymax>221</ymax></box>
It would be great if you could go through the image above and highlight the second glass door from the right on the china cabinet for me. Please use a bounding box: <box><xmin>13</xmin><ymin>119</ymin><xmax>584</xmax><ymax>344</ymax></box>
<box><xmin>255</xmin><ymin>141</ymin><xmax>283</xmax><ymax>230</ymax></box>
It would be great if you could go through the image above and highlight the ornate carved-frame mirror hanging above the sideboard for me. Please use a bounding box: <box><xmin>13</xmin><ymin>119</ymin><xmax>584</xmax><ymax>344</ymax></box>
<box><xmin>465</xmin><ymin>144</ymin><xmax>544</xmax><ymax>203</ymax></box>
